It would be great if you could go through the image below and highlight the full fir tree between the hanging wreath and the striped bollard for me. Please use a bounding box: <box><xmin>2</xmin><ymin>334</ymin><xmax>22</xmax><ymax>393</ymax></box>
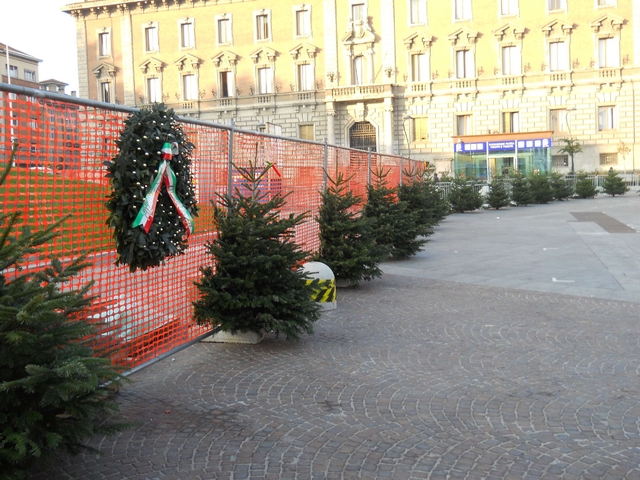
<box><xmin>194</xmin><ymin>165</ymin><xmax>320</xmax><ymax>340</ymax></box>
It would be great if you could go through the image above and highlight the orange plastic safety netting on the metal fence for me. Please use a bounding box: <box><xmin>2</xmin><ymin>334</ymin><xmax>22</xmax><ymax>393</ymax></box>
<box><xmin>0</xmin><ymin>86</ymin><xmax>422</xmax><ymax>368</ymax></box>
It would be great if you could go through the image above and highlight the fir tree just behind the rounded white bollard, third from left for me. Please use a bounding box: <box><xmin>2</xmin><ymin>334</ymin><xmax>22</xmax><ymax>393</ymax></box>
<box><xmin>316</xmin><ymin>173</ymin><xmax>386</xmax><ymax>285</ymax></box>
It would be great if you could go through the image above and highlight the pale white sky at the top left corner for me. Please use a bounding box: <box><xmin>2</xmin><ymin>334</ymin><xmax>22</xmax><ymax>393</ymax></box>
<box><xmin>0</xmin><ymin>0</ymin><xmax>78</xmax><ymax>93</ymax></box>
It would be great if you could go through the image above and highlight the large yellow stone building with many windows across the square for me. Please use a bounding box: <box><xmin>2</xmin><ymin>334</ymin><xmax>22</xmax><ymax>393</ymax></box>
<box><xmin>64</xmin><ymin>0</ymin><xmax>640</xmax><ymax>178</ymax></box>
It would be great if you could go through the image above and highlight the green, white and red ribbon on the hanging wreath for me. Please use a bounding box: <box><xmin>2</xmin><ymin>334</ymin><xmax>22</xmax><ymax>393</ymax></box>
<box><xmin>132</xmin><ymin>142</ymin><xmax>194</xmax><ymax>236</ymax></box>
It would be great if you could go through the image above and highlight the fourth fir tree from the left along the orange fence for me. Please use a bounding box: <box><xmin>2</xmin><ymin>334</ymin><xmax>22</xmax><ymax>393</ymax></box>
<box><xmin>364</xmin><ymin>169</ymin><xmax>426</xmax><ymax>258</ymax></box>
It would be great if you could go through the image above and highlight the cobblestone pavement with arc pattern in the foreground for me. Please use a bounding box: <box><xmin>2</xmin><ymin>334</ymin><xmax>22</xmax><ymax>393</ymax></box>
<box><xmin>34</xmin><ymin>275</ymin><xmax>640</xmax><ymax>479</ymax></box>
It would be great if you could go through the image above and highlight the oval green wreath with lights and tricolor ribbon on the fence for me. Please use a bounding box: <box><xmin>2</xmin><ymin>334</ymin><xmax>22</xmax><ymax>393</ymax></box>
<box><xmin>105</xmin><ymin>104</ymin><xmax>198</xmax><ymax>272</ymax></box>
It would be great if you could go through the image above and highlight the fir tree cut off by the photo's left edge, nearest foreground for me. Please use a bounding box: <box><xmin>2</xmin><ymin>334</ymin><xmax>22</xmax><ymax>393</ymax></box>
<box><xmin>0</xmin><ymin>144</ymin><xmax>127</xmax><ymax>479</ymax></box>
